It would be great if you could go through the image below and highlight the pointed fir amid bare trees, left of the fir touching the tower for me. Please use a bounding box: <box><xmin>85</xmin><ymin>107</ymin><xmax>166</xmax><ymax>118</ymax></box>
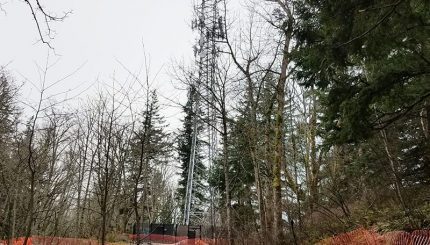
<box><xmin>129</xmin><ymin>90</ymin><xmax>171</xmax><ymax>229</ymax></box>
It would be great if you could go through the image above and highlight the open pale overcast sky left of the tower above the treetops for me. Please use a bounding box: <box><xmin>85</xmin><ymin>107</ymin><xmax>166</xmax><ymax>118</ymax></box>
<box><xmin>0</xmin><ymin>0</ymin><xmax>202</xmax><ymax>129</ymax></box>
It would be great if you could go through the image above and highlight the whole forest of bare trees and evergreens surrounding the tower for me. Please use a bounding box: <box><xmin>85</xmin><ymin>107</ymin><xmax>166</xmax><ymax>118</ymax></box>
<box><xmin>0</xmin><ymin>0</ymin><xmax>430</xmax><ymax>244</ymax></box>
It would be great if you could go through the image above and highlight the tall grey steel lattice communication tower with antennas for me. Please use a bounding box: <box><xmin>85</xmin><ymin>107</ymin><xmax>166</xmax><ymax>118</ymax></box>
<box><xmin>183</xmin><ymin>0</ymin><xmax>225</xmax><ymax>227</ymax></box>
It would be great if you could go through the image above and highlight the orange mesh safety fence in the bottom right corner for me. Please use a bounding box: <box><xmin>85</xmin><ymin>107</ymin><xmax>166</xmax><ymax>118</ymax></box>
<box><xmin>319</xmin><ymin>228</ymin><xmax>430</xmax><ymax>245</ymax></box>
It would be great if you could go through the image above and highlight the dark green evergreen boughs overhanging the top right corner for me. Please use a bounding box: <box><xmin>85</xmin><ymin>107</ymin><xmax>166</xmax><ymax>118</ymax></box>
<box><xmin>295</xmin><ymin>0</ymin><xmax>430</xmax><ymax>143</ymax></box>
